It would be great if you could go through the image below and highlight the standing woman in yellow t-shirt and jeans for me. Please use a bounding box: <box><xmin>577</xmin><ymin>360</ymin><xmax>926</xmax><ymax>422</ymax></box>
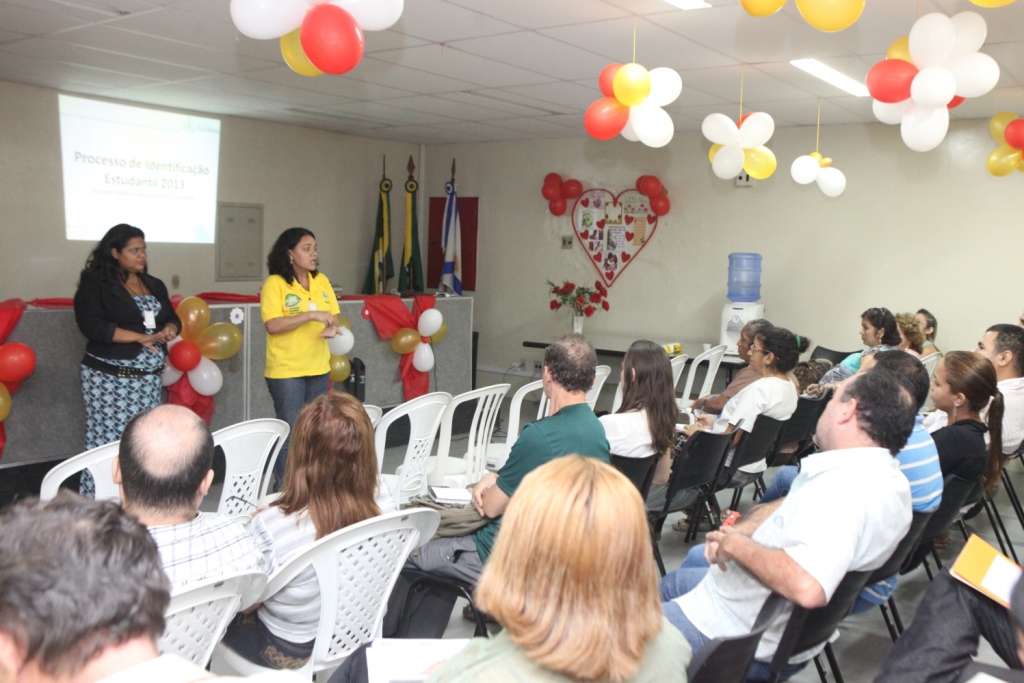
<box><xmin>260</xmin><ymin>227</ymin><xmax>341</xmax><ymax>483</ymax></box>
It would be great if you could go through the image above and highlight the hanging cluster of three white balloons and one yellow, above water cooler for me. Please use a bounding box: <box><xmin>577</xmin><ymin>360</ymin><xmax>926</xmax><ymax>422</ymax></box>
<box><xmin>700</xmin><ymin>112</ymin><xmax>778</xmax><ymax>180</ymax></box>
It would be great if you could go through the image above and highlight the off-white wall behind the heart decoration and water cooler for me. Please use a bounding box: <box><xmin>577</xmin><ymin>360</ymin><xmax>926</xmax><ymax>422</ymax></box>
<box><xmin>427</xmin><ymin>120</ymin><xmax>1024</xmax><ymax>368</ymax></box>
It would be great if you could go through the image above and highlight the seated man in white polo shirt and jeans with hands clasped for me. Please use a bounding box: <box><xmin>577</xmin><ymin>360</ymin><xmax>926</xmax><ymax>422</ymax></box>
<box><xmin>660</xmin><ymin>372</ymin><xmax>916</xmax><ymax>680</ymax></box>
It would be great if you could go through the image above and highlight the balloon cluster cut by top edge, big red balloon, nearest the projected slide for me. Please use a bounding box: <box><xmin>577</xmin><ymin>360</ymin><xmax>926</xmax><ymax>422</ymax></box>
<box><xmin>231</xmin><ymin>0</ymin><xmax>404</xmax><ymax>76</ymax></box>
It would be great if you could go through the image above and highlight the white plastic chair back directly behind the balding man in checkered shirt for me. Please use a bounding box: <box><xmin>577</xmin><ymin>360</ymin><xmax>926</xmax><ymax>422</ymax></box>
<box><xmin>159</xmin><ymin>571</ymin><xmax>266</xmax><ymax>669</ymax></box>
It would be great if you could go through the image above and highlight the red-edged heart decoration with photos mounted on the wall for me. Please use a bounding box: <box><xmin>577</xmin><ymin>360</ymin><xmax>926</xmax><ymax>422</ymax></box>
<box><xmin>572</xmin><ymin>188</ymin><xmax>657</xmax><ymax>287</ymax></box>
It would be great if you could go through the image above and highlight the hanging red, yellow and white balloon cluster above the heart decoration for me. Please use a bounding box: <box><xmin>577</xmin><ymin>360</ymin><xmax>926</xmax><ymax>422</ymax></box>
<box><xmin>583</xmin><ymin>62</ymin><xmax>683</xmax><ymax>147</ymax></box>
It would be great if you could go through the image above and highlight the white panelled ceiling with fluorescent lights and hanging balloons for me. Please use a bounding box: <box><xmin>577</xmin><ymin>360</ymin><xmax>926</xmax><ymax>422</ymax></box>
<box><xmin>0</xmin><ymin>0</ymin><xmax>1024</xmax><ymax>142</ymax></box>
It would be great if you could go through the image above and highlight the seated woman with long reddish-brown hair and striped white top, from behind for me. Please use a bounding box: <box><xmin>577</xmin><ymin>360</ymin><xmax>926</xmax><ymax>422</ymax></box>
<box><xmin>223</xmin><ymin>393</ymin><xmax>395</xmax><ymax>669</ymax></box>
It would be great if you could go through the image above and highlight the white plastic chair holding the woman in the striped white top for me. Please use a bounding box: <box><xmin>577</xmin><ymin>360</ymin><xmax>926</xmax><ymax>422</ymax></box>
<box><xmin>211</xmin><ymin>509</ymin><xmax>440</xmax><ymax>680</ymax></box>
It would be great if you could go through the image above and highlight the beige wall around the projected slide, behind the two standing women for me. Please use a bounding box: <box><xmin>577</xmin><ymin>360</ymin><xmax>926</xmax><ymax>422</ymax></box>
<box><xmin>0</xmin><ymin>82</ymin><xmax>419</xmax><ymax>299</ymax></box>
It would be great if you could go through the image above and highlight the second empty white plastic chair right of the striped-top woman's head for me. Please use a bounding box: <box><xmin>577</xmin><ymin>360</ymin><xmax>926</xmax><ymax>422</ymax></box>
<box><xmin>427</xmin><ymin>384</ymin><xmax>512</xmax><ymax>488</ymax></box>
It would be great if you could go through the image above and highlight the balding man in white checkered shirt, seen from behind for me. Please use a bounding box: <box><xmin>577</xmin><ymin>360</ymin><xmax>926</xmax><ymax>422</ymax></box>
<box><xmin>114</xmin><ymin>405</ymin><xmax>269</xmax><ymax>590</ymax></box>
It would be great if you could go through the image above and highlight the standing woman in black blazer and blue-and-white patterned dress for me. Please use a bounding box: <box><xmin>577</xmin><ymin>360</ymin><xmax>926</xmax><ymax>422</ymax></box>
<box><xmin>75</xmin><ymin>223</ymin><xmax>181</xmax><ymax>496</ymax></box>
